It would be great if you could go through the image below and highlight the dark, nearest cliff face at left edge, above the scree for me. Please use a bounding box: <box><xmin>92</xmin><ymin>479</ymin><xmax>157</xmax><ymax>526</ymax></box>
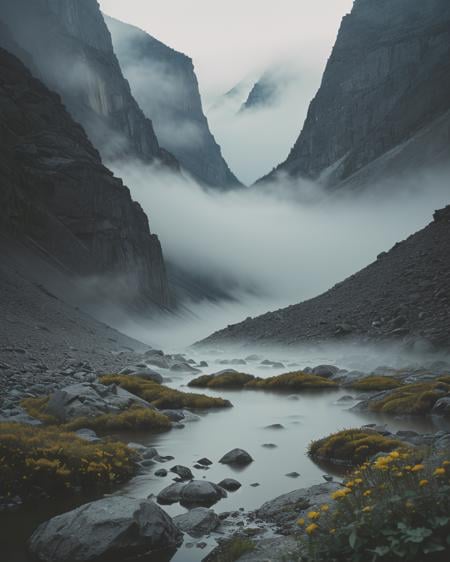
<box><xmin>0</xmin><ymin>49</ymin><xmax>171</xmax><ymax>307</ymax></box>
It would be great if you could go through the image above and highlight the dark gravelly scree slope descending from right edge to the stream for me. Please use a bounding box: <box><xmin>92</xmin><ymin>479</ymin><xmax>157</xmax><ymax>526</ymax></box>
<box><xmin>200</xmin><ymin>206</ymin><xmax>450</xmax><ymax>349</ymax></box>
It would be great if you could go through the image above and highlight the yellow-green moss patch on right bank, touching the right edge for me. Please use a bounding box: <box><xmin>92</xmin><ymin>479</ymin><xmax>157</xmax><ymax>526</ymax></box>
<box><xmin>369</xmin><ymin>377</ymin><xmax>450</xmax><ymax>416</ymax></box>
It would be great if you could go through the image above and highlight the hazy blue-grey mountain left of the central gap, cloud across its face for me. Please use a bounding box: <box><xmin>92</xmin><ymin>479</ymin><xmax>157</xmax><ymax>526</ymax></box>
<box><xmin>105</xmin><ymin>17</ymin><xmax>241</xmax><ymax>188</ymax></box>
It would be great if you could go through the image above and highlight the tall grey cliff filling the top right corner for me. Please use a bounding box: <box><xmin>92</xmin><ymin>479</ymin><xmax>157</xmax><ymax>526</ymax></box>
<box><xmin>260</xmin><ymin>0</ymin><xmax>450</xmax><ymax>189</ymax></box>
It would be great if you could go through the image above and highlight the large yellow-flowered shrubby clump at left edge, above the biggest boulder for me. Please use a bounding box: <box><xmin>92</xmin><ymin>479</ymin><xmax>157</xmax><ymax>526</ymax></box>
<box><xmin>0</xmin><ymin>423</ymin><xmax>138</xmax><ymax>499</ymax></box>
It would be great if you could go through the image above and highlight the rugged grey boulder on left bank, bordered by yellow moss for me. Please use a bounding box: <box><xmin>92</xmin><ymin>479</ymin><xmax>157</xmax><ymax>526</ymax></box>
<box><xmin>46</xmin><ymin>382</ymin><xmax>152</xmax><ymax>422</ymax></box>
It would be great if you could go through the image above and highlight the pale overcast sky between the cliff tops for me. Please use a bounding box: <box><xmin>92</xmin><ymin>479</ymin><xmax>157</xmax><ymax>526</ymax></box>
<box><xmin>99</xmin><ymin>0</ymin><xmax>353</xmax><ymax>98</ymax></box>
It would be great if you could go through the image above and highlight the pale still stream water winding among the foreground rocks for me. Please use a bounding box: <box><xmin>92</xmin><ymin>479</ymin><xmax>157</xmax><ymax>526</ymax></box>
<box><xmin>0</xmin><ymin>352</ymin><xmax>446</xmax><ymax>562</ymax></box>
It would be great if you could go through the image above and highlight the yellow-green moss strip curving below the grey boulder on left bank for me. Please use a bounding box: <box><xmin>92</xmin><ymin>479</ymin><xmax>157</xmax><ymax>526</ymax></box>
<box><xmin>21</xmin><ymin>396</ymin><xmax>171</xmax><ymax>433</ymax></box>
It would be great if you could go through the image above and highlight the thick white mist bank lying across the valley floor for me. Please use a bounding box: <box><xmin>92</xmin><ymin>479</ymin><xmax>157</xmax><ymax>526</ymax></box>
<box><xmin>109</xmin><ymin>158</ymin><xmax>448</xmax><ymax>348</ymax></box>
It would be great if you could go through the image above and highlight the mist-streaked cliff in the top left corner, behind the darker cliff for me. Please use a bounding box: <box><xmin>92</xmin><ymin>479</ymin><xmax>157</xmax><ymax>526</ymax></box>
<box><xmin>0</xmin><ymin>0</ymin><xmax>177</xmax><ymax>168</ymax></box>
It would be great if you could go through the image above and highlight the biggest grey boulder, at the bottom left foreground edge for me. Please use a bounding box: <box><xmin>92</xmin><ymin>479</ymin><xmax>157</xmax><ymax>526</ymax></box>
<box><xmin>30</xmin><ymin>496</ymin><xmax>183</xmax><ymax>562</ymax></box>
